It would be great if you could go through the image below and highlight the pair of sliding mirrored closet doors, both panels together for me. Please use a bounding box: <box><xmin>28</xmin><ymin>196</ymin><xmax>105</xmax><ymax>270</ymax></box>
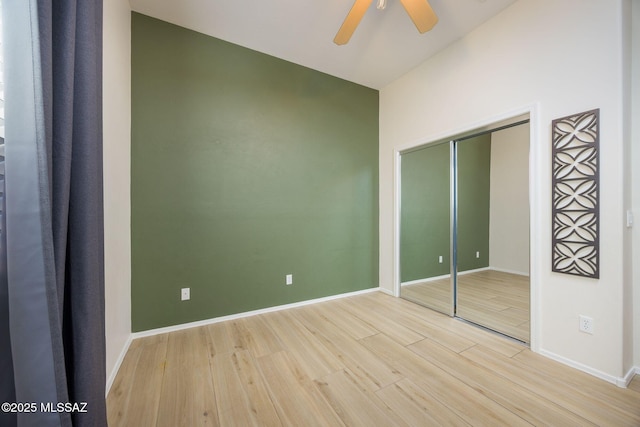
<box><xmin>400</xmin><ymin>118</ymin><xmax>530</xmax><ymax>342</ymax></box>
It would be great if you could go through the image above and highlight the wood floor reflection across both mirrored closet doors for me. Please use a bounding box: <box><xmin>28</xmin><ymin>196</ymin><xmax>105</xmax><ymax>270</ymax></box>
<box><xmin>402</xmin><ymin>270</ymin><xmax>530</xmax><ymax>342</ymax></box>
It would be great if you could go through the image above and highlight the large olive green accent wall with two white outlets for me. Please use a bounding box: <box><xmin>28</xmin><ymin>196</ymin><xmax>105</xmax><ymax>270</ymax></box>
<box><xmin>131</xmin><ymin>13</ymin><xmax>378</xmax><ymax>331</ymax></box>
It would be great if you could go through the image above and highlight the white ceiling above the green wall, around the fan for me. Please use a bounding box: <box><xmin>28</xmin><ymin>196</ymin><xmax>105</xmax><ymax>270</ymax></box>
<box><xmin>130</xmin><ymin>0</ymin><xmax>516</xmax><ymax>89</ymax></box>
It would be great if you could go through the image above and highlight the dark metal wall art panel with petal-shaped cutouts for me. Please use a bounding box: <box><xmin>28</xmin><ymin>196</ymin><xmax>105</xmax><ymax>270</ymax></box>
<box><xmin>551</xmin><ymin>109</ymin><xmax>600</xmax><ymax>279</ymax></box>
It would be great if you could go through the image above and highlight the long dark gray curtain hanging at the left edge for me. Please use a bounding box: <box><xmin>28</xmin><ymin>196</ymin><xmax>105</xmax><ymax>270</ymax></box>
<box><xmin>0</xmin><ymin>0</ymin><xmax>106</xmax><ymax>426</ymax></box>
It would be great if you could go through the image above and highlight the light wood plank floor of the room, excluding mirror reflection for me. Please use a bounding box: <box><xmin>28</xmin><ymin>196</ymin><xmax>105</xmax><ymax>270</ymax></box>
<box><xmin>107</xmin><ymin>292</ymin><xmax>640</xmax><ymax>427</ymax></box>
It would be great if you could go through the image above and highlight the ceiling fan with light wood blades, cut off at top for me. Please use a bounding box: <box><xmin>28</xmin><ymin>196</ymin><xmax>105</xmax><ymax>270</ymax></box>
<box><xmin>333</xmin><ymin>0</ymin><xmax>438</xmax><ymax>45</ymax></box>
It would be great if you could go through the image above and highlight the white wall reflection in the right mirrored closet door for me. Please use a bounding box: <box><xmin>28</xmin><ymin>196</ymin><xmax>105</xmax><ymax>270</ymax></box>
<box><xmin>489</xmin><ymin>124</ymin><xmax>529</xmax><ymax>275</ymax></box>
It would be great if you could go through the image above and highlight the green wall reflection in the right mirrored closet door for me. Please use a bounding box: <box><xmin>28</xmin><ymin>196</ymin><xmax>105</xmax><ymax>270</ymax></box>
<box><xmin>458</xmin><ymin>133</ymin><xmax>491</xmax><ymax>272</ymax></box>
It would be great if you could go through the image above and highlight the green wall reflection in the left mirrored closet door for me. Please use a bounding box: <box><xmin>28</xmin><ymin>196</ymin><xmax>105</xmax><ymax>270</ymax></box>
<box><xmin>400</xmin><ymin>143</ymin><xmax>451</xmax><ymax>282</ymax></box>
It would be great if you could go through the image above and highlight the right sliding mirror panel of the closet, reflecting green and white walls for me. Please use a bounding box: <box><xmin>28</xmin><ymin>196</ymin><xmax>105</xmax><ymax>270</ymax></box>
<box><xmin>456</xmin><ymin>124</ymin><xmax>530</xmax><ymax>342</ymax></box>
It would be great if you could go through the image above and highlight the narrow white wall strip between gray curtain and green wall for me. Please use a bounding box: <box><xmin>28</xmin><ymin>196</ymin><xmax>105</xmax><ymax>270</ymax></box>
<box><xmin>103</xmin><ymin>0</ymin><xmax>131</xmax><ymax>392</ymax></box>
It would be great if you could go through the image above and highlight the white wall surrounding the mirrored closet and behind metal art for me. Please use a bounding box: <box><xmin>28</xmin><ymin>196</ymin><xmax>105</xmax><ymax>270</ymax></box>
<box><xmin>380</xmin><ymin>0</ymin><xmax>631</xmax><ymax>381</ymax></box>
